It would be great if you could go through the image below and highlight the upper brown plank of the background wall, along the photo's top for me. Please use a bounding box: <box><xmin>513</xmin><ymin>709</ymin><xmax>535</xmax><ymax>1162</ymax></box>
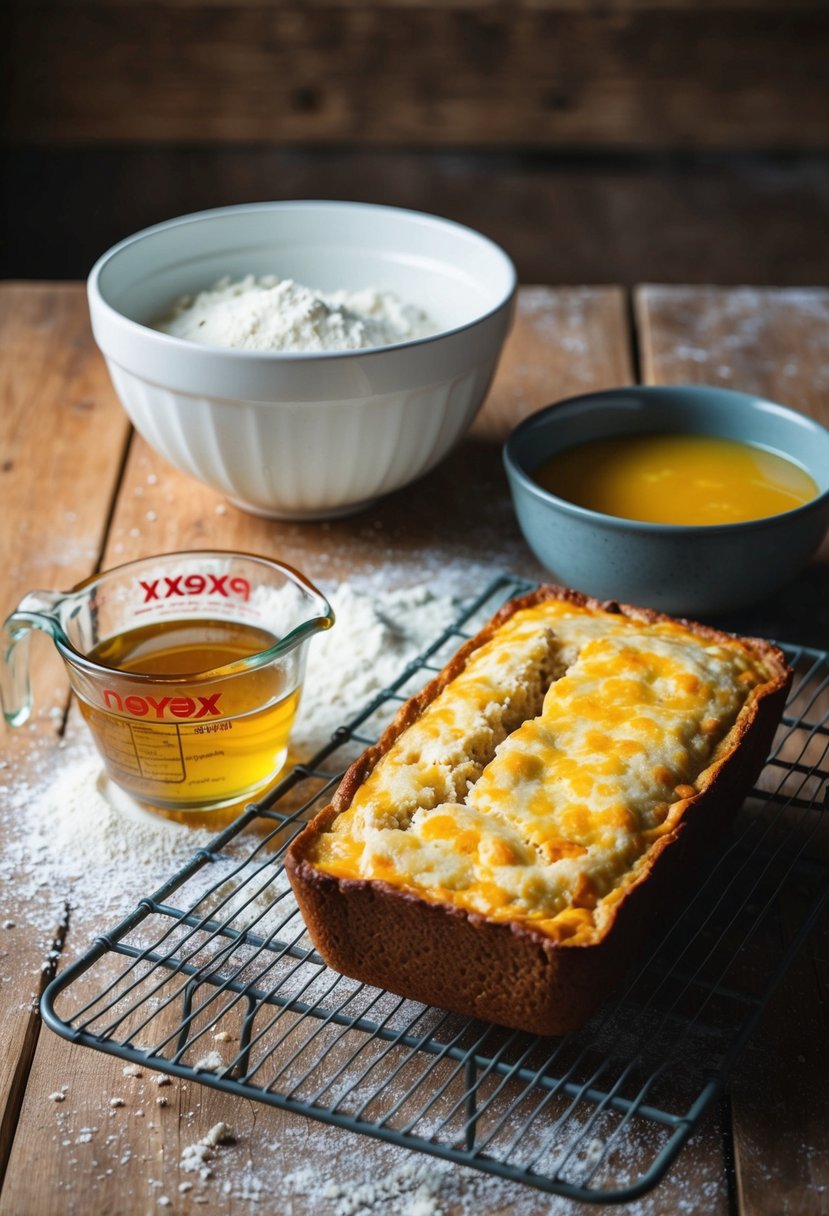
<box><xmin>2</xmin><ymin>0</ymin><xmax>829</xmax><ymax>152</ymax></box>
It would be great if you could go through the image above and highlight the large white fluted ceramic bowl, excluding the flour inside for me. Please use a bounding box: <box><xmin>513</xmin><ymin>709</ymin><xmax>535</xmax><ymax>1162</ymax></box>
<box><xmin>88</xmin><ymin>202</ymin><xmax>515</xmax><ymax>519</ymax></box>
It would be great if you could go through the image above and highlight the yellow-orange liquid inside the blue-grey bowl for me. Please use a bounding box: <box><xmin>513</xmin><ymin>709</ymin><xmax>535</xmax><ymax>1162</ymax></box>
<box><xmin>534</xmin><ymin>434</ymin><xmax>818</xmax><ymax>524</ymax></box>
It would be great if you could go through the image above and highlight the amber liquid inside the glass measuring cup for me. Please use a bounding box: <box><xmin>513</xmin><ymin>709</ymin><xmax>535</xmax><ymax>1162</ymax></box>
<box><xmin>77</xmin><ymin>619</ymin><xmax>300</xmax><ymax>810</ymax></box>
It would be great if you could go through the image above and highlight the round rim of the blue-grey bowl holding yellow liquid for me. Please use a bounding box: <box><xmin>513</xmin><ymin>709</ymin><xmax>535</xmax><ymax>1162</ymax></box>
<box><xmin>502</xmin><ymin>383</ymin><xmax>829</xmax><ymax>537</ymax></box>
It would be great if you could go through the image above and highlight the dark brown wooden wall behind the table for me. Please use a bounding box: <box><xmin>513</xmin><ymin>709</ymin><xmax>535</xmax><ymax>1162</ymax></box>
<box><xmin>0</xmin><ymin>0</ymin><xmax>829</xmax><ymax>285</ymax></box>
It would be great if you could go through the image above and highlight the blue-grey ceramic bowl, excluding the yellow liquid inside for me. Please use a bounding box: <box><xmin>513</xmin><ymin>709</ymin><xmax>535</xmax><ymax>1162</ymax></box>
<box><xmin>503</xmin><ymin>385</ymin><xmax>829</xmax><ymax>615</ymax></box>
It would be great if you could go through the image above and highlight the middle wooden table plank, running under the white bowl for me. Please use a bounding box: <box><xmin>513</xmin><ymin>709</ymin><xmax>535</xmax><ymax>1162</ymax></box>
<box><xmin>0</xmin><ymin>279</ymin><xmax>695</xmax><ymax>1216</ymax></box>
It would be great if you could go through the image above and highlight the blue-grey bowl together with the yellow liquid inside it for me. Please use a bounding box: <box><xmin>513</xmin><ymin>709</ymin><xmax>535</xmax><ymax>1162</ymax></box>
<box><xmin>503</xmin><ymin>384</ymin><xmax>829</xmax><ymax>617</ymax></box>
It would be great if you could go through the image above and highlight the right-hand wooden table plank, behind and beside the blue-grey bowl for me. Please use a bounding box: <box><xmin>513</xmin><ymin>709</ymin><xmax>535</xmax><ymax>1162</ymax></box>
<box><xmin>636</xmin><ymin>287</ymin><xmax>829</xmax><ymax>1216</ymax></box>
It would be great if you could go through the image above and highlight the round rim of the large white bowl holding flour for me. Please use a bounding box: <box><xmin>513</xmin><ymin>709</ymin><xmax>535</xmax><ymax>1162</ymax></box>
<box><xmin>86</xmin><ymin>198</ymin><xmax>518</xmax><ymax>364</ymax></box>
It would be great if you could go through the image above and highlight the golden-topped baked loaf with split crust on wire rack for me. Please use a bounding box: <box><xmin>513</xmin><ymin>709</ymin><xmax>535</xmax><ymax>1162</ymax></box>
<box><xmin>286</xmin><ymin>586</ymin><xmax>790</xmax><ymax>1035</ymax></box>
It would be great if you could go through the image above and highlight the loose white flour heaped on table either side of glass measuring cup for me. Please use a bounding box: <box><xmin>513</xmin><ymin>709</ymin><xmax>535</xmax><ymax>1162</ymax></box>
<box><xmin>0</xmin><ymin>584</ymin><xmax>457</xmax><ymax>931</ymax></box>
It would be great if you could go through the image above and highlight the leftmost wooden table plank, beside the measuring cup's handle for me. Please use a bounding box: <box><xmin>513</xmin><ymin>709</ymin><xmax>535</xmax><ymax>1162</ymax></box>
<box><xmin>0</xmin><ymin>283</ymin><xmax>130</xmax><ymax>1173</ymax></box>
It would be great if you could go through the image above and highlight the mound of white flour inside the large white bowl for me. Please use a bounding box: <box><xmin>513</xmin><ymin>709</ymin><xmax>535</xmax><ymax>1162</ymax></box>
<box><xmin>156</xmin><ymin>275</ymin><xmax>438</xmax><ymax>353</ymax></box>
